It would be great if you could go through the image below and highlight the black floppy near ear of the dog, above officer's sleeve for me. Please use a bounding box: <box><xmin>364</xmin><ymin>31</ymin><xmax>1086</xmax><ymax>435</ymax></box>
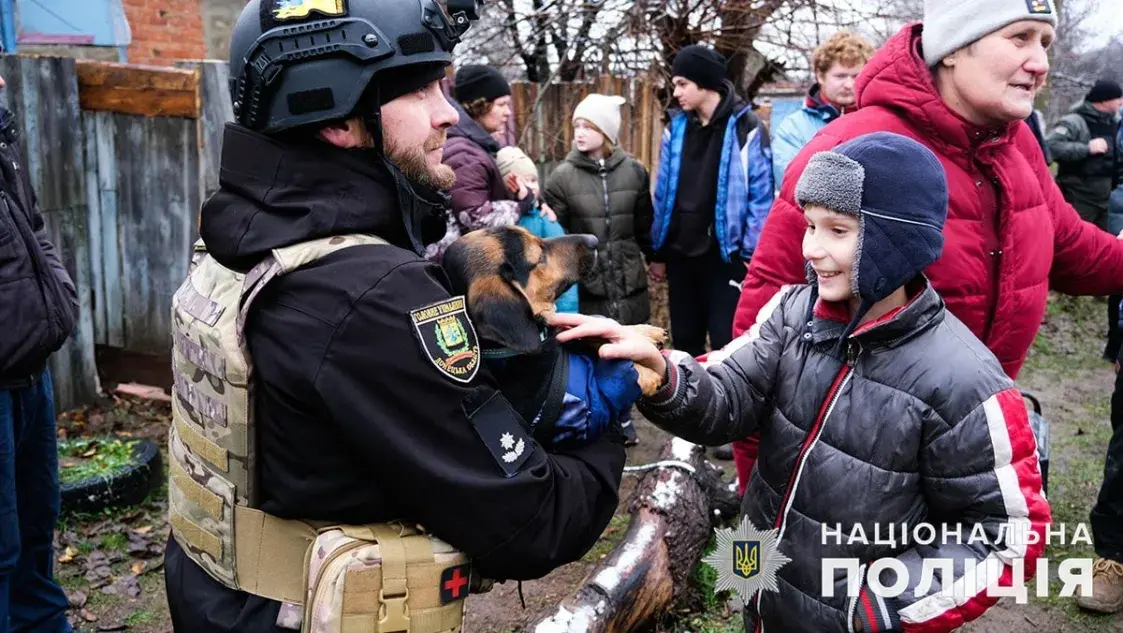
<box><xmin>468</xmin><ymin>274</ymin><xmax>542</xmax><ymax>354</ymax></box>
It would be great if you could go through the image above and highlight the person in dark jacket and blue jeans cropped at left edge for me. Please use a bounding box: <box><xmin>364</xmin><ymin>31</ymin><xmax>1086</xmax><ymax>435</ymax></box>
<box><xmin>0</xmin><ymin>65</ymin><xmax>77</xmax><ymax>633</ymax></box>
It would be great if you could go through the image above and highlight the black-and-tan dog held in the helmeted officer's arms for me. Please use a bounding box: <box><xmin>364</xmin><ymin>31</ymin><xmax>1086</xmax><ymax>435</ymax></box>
<box><xmin>442</xmin><ymin>227</ymin><xmax>667</xmax><ymax>395</ymax></box>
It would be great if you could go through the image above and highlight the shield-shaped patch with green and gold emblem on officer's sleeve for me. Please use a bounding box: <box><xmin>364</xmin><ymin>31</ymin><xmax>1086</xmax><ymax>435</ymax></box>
<box><xmin>410</xmin><ymin>295</ymin><xmax>480</xmax><ymax>383</ymax></box>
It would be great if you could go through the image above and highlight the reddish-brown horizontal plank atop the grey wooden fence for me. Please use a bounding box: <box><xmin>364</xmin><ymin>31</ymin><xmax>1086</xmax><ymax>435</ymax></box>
<box><xmin>76</xmin><ymin>59</ymin><xmax>202</xmax><ymax>119</ymax></box>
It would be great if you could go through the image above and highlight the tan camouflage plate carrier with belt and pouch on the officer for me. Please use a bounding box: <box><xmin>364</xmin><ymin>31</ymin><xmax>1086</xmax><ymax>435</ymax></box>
<box><xmin>168</xmin><ymin>235</ymin><xmax>469</xmax><ymax>633</ymax></box>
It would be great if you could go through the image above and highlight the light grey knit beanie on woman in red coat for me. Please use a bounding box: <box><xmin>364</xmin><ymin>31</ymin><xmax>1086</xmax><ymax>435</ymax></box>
<box><xmin>921</xmin><ymin>0</ymin><xmax>1057</xmax><ymax>66</ymax></box>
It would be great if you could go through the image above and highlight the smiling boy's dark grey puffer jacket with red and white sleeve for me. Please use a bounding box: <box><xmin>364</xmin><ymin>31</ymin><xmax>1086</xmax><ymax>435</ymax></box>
<box><xmin>640</xmin><ymin>283</ymin><xmax>1051</xmax><ymax>633</ymax></box>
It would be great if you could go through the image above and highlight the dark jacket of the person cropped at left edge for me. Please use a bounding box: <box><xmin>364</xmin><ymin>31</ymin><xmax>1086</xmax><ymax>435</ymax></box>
<box><xmin>0</xmin><ymin>109</ymin><xmax>77</xmax><ymax>389</ymax></box>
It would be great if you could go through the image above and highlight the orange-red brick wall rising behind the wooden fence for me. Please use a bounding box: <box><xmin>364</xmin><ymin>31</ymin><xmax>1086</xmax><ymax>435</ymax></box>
<box><xmin>124</xmin><ymin>0</ymin><xmax>207</xmax><ymax>65</ymax></box>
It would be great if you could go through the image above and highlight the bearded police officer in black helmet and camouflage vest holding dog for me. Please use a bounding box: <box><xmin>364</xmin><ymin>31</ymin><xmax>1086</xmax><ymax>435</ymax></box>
<box><xmin>165</xmin><ymin>0</ymin><xmax>624</xmax><ymax>633</ymax></box>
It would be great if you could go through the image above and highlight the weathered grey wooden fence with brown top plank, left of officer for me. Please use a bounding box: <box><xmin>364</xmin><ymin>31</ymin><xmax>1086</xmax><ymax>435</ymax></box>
<box><xmin>0</xmin><ymin>56</ymin><xmax>228</xmax><ymax>410</ymax></box>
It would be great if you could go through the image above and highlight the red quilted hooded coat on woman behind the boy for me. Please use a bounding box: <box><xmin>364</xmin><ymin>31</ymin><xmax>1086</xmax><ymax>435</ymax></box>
<box><xmin>733</xmin><ymin>24</ymin><xmax>1123</xmax><ymax>492</ymax></box>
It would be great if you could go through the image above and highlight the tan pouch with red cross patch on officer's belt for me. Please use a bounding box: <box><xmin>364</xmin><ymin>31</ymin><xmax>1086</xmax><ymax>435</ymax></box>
<box><xmin>276</xmin><ymin>524</ymin><xmax>471</xmax><ymax>633</ymax></box>
